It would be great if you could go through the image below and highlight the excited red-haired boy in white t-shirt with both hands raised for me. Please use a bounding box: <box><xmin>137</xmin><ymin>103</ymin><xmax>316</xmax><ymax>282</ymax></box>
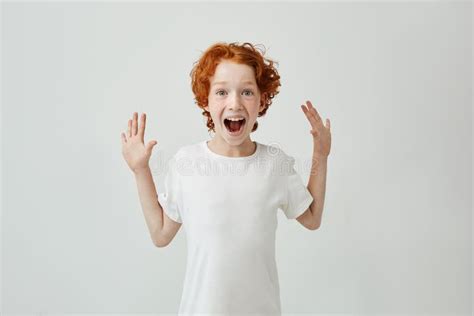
<box><xmin>122</xmin><ymin>43</ymin><xmax>331</xmax><ymax>315</ymax></box>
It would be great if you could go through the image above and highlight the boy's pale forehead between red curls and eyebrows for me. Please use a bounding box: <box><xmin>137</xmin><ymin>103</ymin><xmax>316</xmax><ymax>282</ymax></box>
<box><xmin>209</xmin><ymin>61</ymin><xmax>256</xmax><ymax>85</ymax></box>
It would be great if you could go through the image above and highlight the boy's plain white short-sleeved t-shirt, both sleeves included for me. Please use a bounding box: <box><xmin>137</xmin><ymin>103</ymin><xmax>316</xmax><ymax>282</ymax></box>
<box><xmin>158</xmin><ymin>141</ymin><xmax>313</xmax><ymax>315</ymax></box>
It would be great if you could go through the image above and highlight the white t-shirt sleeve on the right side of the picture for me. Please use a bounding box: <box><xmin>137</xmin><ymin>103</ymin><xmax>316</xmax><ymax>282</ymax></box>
<box><xmin>280</xmin><ymin>156</ymin><xmax>313</xmax><ymax>219</ymax></box>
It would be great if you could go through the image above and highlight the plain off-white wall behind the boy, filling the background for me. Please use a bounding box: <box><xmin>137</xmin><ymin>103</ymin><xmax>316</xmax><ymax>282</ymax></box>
<box><xmin>1</xmin><ymin>1</ymin><xmax>472</xmax><ymax>315</ymax></box>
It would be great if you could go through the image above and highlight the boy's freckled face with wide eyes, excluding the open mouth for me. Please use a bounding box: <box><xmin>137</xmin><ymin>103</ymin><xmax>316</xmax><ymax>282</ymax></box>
<box><xmin>205</xmin><ymin>60</ymin><xmax>264</xmax><ymax>145</ymax></box>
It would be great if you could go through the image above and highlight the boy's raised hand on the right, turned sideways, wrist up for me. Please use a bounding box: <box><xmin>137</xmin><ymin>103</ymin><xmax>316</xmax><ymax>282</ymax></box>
<box><xmin>301</xmin><ymin>101</ymin><xmax>331</xmax><ymax>158</ymax></box>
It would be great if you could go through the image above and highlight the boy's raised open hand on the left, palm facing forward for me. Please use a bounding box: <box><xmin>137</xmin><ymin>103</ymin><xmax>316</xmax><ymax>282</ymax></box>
<box><xmin>121</xmin><ymin>112</ymin><xmax>157</xmax><ymax>173</ymax></box>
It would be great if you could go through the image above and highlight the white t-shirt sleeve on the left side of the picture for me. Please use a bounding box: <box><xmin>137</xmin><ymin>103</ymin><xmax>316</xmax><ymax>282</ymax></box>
<box><xmin>158</xmin><ymin>157</ymin><xmax>183</xmax><ymax>223</ymax></box>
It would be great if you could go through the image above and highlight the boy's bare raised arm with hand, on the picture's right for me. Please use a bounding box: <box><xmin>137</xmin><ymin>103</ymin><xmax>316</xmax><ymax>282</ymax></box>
<box><xmin>297</xmin><ymin>101</ymin><xmax>331</xmax><ymax>230</ymax></box>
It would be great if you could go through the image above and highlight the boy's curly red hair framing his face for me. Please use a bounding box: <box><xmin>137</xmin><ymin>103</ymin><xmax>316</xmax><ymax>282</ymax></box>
<box><xmin>190</xmin><ymin>42</ymin><xmax>281</xmax><ymax>132</ymax></box>
